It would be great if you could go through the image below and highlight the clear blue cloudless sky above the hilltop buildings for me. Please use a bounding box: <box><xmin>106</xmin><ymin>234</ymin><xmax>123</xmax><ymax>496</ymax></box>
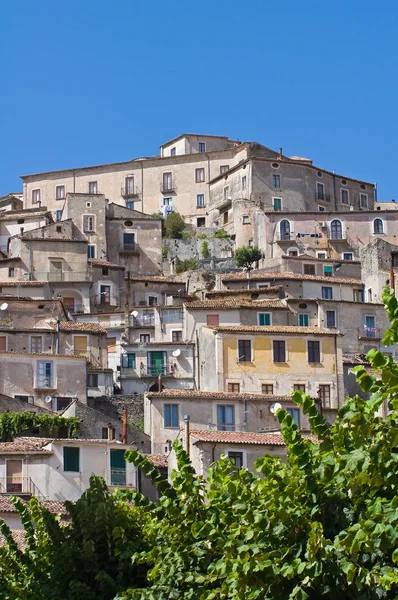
<box><xmin>0</xmin><ymin>0</ymin><xmax>398</xmax><ymax>200</ymax></box>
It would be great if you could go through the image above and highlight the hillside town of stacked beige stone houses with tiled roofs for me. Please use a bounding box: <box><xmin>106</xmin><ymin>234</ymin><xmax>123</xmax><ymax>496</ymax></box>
<box><xmin>0</xmin><ymin>134</ymin><xmax>398</xmax><ymax>530</ymax></box>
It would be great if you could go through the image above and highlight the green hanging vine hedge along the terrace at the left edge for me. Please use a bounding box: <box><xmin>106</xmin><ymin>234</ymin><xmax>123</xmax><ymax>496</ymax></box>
<box><xmin>0</xmin><ymin>411</ymin><xmax>80</xmax><ymax>442</ymax></box>
